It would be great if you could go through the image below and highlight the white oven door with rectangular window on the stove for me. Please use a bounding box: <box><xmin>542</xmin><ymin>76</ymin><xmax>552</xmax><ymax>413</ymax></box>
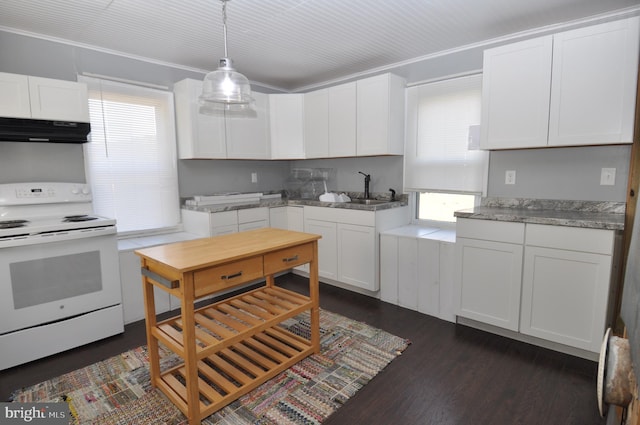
<box><xmin>0</xmin><ymin>227</ymin><xmax>122</xmax><ymax>334</ymax></box>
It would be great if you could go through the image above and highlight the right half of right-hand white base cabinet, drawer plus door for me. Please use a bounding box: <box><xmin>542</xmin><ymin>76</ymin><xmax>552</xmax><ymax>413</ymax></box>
<box><xmin>520</xmin><ymin>224</ymin><xmax>614</xmax><ymax>352</ymax></box>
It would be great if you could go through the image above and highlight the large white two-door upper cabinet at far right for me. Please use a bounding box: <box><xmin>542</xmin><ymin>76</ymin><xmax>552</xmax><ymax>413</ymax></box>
<box><xmin>480</xmin><ymin>17</ymin><xmax>640</xmax><ymax>149</ymax></box>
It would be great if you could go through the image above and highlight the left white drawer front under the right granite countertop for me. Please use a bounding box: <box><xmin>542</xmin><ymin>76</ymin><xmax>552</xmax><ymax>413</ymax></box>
<box><xmin>456</xmin><ymin>218</ymin><xmax>524</xmax><ymax>244</ymax></box>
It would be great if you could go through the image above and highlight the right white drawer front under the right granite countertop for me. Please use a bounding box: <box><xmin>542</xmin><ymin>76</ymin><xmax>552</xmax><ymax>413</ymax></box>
<box><xmin>526</xmin><ymin>224</ymin><xmax>614</xmax><ymax>255</ymax></box>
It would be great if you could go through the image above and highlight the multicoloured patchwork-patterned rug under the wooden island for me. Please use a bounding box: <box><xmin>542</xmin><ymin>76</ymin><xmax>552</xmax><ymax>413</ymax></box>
<box><xmin>13</xmin><ymin>310</ymin><xmax>409</xmax><ymax>425</ymax></box>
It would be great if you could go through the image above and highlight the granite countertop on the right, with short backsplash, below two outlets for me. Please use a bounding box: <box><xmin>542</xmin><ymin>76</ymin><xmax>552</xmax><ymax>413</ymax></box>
<box><xmin>454</xmin><ymin>198</ymin><xmax>625</xmax><ymax>230</ymax></box>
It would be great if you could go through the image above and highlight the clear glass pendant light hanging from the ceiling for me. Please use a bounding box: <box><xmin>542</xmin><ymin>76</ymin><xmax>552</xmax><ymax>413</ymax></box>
<box><xmin>199</xmin><ymin>0</ymin><xmax>253</xmax><ymax>115</ymax></box>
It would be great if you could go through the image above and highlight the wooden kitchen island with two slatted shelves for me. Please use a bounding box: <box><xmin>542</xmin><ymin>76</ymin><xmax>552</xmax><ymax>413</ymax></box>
<box><xmin>135</xmin><ymin>228</ymin><xmax>320</xmax><ymax>424</ymax></box>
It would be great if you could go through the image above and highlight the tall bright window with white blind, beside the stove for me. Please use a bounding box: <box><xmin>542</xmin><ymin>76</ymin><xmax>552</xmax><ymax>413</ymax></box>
<box><xmin>78</xmin><ymin>76</ymin><xmax>180</xmax><ymax>233</ymax></box>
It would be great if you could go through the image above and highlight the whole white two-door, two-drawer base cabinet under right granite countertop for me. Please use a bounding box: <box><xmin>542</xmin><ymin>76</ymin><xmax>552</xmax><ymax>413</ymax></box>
<box><xmin>455</xmin><ymin>218</ymin><xmax>615</xmax><ymax>353</ymax></box>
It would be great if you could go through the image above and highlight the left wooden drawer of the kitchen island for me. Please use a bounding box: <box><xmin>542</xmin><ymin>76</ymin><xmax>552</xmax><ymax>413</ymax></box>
<box><xmin>193</xmin><ymin>256</ymin><xmax>263</xmax><ymax>298</ymax></box>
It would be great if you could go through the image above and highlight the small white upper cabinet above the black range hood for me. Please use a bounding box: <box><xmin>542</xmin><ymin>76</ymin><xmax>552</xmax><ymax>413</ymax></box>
<box><xmin>0</xmin><ymin>73</ymin><xmax>89</xmax><ymax>122</ymax></box>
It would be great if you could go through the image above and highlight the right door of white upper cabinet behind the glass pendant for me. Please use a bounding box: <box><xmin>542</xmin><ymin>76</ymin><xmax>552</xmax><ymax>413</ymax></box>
<box><xmin>225</xmin><ymin>92</ymin><xmax>271</xmax><ymax>159</ymax></box>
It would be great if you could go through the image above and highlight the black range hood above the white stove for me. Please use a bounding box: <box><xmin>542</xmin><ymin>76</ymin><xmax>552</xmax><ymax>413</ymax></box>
<box><xmin>0</xmin><ymin>118</ymin><xmax>91</xmax><ymax>143</ymax></box>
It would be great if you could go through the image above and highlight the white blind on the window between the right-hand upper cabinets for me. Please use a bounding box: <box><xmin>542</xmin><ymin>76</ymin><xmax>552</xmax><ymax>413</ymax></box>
<box><xmin>404</xmin><ymin>75</ymin><xmax>488</xmax><ymax>193</ymax></box>
